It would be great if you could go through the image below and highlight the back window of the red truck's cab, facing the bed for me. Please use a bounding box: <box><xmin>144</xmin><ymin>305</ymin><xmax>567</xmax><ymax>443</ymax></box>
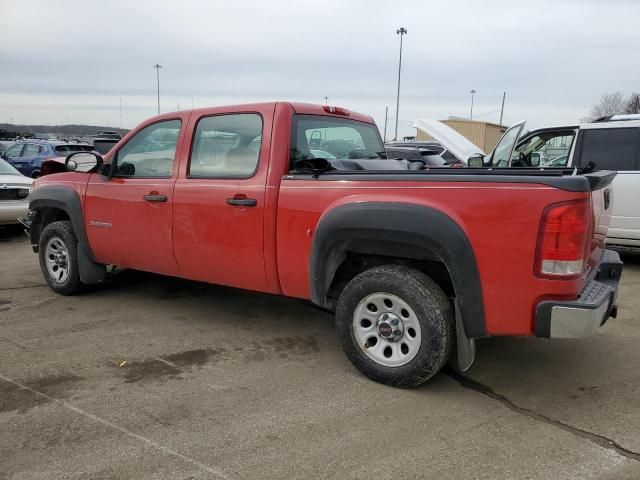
<box><xmin>290</xmin><ymin>115</ymin><xmax>385</xmax><ymax>166</ymax></box>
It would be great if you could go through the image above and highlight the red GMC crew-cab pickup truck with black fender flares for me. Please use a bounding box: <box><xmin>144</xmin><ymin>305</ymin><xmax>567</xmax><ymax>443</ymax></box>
<box><xmin>23</xmin><ymin>102</ymin><xmax>622</xmax><ymax>387</ymax></box>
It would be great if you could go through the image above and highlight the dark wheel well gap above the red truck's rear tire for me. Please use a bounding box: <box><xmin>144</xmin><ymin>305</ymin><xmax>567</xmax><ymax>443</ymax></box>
<box><xmin>327</xmin><ymin>252</ymin><xmax>455</xmax><ymax>309</ymax></box>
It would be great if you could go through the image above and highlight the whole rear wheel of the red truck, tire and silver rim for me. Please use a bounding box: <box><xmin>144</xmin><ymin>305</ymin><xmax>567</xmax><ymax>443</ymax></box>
<box><xmin>336</xmin><ymin>265</ymin><xmax>453</xmax><ymax>388</ymax></box>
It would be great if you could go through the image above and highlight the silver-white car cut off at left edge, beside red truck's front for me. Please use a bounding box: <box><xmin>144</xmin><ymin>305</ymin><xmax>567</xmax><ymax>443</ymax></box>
<box><xmin>0</xmin><ymin>159</ymin><xmax>33</xmax><ymax>225</ymax></box>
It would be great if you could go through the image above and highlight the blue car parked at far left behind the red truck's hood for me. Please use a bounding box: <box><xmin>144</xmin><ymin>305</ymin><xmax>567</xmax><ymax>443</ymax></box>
<box><xmin>2</xmin><ymin>139</ymin><xmax>93</xmax><ymax>178</ymax></box>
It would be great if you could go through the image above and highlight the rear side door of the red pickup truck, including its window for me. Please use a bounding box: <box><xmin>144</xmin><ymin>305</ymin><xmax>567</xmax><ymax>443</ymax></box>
<box><xmin>173</xmin><ymin>105</ymin><xmax>274</xmax><ymax>291</ymax></box>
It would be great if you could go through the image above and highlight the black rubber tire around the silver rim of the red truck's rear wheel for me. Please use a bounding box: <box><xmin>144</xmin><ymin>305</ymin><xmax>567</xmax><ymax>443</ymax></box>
<box><xmin>336</xmin><ymin>265</ymin><xmax>454</xmax><ymax>388</ymax></box>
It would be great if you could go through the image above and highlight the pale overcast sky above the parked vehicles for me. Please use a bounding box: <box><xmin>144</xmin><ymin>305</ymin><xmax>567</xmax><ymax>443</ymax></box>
<box><xmin>0</xmin><ymin>0</ymin><xmax>640</xmax><ymax>135</ymax></box>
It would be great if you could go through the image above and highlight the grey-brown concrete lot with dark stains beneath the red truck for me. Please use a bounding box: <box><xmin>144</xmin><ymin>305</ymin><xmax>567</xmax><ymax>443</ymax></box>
<box><xmin>0</xmin><ymin>226</ymin><xmax>640</xmax><ymax>480</ymax></box>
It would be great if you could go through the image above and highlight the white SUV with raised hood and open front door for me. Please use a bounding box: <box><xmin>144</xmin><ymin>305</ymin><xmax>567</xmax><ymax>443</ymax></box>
<box><xmin>414</xmin><ymin>114</ymin><xmax>640</xmax><ymax>250</ymax></box>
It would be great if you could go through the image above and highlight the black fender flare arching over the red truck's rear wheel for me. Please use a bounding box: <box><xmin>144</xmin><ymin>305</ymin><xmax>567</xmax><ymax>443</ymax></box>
<box><xmin>309</xmin><ymin>202</ymin><xmax>487</xmax><ymax>338</ymax></box>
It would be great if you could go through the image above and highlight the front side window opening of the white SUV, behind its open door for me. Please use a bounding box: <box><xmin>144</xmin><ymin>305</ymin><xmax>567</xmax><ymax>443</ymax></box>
<box><xmin>511</xmin><ymin>130</ymin><xmax>576</xmax><ymax>167</ymax></box>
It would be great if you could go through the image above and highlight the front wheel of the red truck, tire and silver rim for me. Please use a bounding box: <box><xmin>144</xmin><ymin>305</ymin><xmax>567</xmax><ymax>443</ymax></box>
<box><xmin>38</xmin><ymin>221</ymin><xmax>82</xmax><ymax>295</ymax></box>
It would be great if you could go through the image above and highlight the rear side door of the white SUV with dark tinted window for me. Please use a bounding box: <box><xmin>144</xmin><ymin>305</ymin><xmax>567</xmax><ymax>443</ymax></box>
<box><xmin>578</xmin><ymin>127</ymin><xmax>640</xmax><ymax>246</ymax></box>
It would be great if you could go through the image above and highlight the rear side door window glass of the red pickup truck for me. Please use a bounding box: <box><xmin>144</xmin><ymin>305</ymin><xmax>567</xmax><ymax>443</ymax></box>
<box><xmin>188</xmin><ymin>113</ymin><xmax>262</xmax><ymax>178</ymax></box>
